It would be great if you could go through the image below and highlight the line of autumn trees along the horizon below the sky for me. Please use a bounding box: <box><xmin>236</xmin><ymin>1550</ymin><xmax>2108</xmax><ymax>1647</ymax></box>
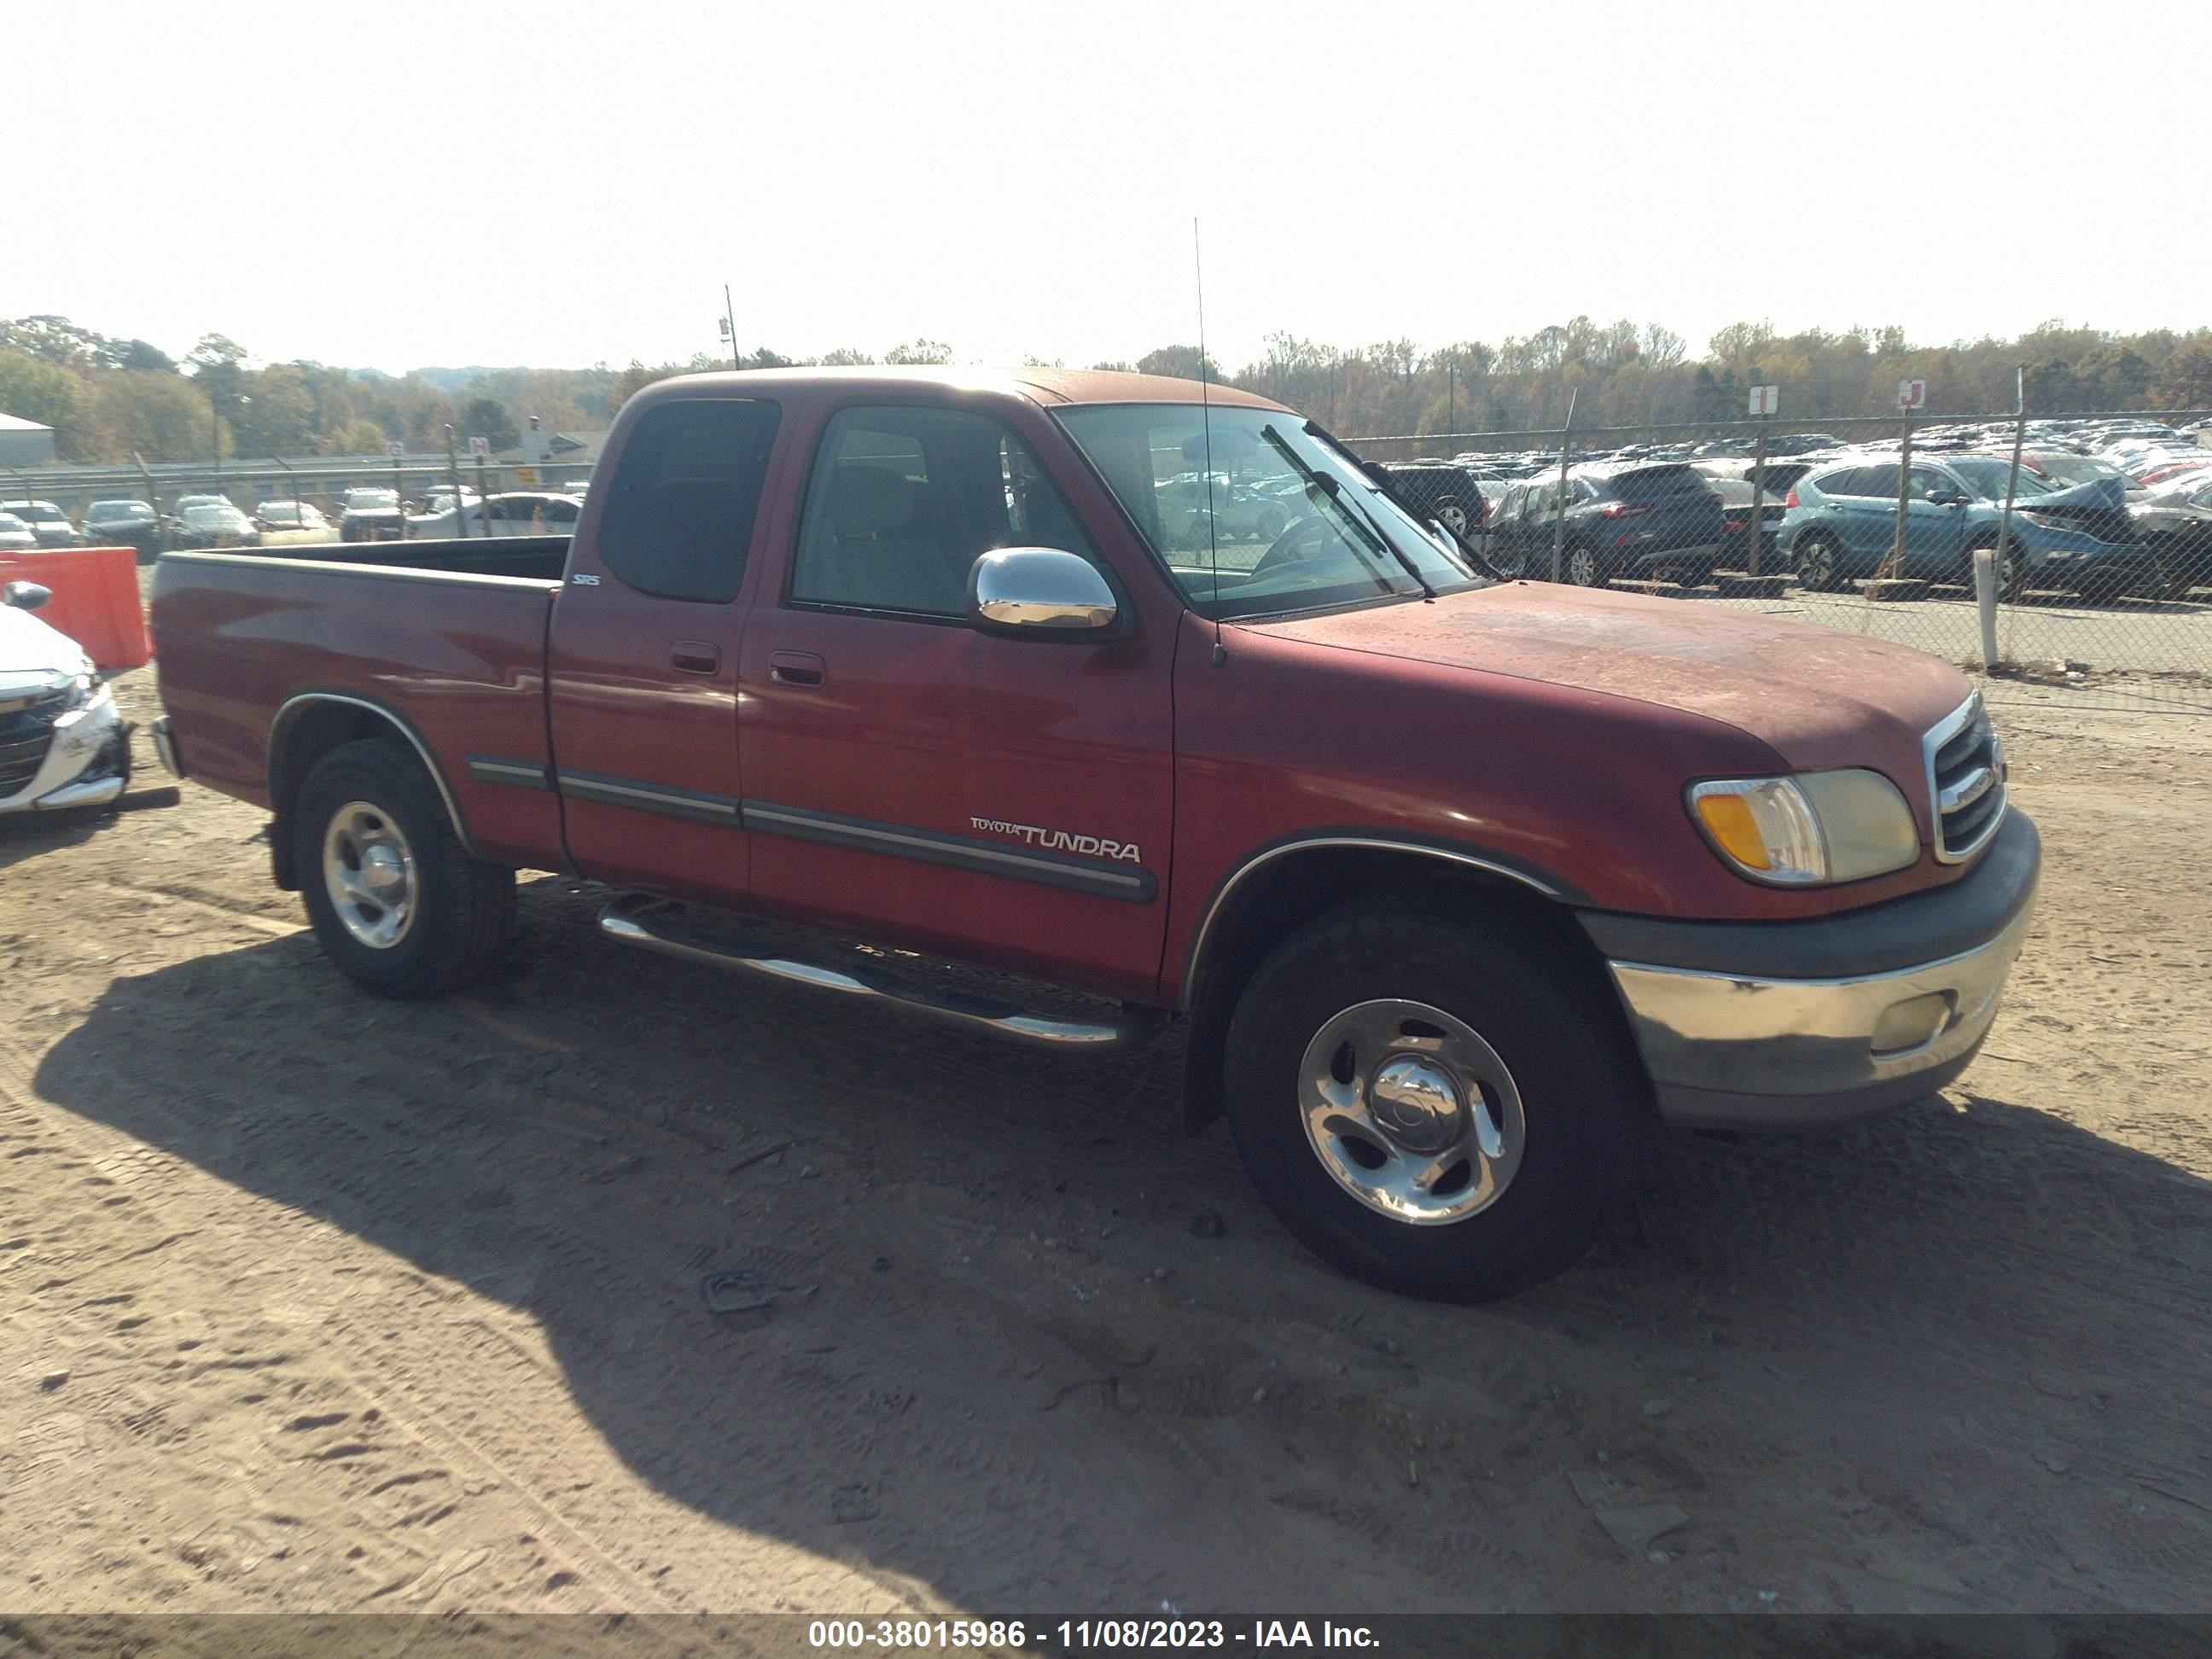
<box><xmin>0</xmin><ymin>317</ymin><xmax>2212</xmax><ymax>463</ymax></box>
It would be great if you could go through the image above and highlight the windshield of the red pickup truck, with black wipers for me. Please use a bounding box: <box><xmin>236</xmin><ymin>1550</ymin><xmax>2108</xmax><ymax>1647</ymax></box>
<box><xmin>1057</xmin><ymin>403</ymin><xmax>1482</xmax><ymax>617</ymax></box>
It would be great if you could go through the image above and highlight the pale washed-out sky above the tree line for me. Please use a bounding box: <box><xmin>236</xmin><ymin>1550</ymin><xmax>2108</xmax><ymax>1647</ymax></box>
<box><xmin>21</xmin><ymin>0</ymin><xmax>2212</xmax><ymax>371</ymax></box>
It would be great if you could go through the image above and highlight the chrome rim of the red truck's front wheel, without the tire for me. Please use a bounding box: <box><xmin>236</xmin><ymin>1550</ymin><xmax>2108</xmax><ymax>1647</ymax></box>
<box><xmin>1299</xmin><ymin>998</ymin><xmax>1526</xmax><ymax>1228</ymax></box>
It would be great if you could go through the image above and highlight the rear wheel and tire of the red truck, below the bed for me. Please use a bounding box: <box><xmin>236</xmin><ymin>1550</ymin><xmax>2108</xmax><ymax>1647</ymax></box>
<box><xmin>292</xmin><ymin>736</ymin><xmax>515</xmax><ymax>1002</ymax></box>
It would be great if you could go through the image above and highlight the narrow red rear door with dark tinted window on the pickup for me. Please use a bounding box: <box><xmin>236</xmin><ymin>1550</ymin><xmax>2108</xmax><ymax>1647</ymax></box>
<box><xmin>546</xmin><ymin>399</ymin><xmax>778</xmax><ymax>905</ymax></box>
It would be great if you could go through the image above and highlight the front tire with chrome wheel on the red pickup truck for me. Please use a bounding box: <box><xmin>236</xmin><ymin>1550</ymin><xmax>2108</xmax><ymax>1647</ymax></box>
<box><xmin>1223</xmin><ymin>905</ymin><xmax>1650</xmax><ymax>1303</ymax></box>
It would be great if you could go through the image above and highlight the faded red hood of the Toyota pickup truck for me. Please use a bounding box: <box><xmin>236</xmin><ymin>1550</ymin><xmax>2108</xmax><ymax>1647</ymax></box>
<box><xmin>1248</xmin><ymin>582</ymin><xmax>1973</xmax><ymax>778</ymax></box>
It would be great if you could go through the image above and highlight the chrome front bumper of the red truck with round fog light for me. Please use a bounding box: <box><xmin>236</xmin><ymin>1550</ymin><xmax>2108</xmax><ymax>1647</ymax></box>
<box><xmin>1608</xmin><ymin>884</ymin><xmax>2033</xmax><ymax>1128</ymax></box>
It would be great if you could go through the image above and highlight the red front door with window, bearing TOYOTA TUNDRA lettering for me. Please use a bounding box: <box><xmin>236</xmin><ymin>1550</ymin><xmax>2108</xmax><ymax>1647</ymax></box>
<box><xmin>739</xmin><ymin>405</ymin><xmax>1173</xmax><ymax>995</ymax></box>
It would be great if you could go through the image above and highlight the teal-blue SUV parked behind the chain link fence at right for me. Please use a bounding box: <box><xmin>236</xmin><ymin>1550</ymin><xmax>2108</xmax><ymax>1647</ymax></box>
<box><xmin>1781</xmin><ymin>456</ymin><xmax>2166</xmax><ymax>599</ymax></box>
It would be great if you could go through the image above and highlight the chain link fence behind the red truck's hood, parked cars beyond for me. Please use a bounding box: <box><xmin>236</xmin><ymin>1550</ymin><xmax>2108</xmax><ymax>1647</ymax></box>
<box><xmin>1348</xmin><ymin>410</ymin><xmax>2212</xmax><ymax>714</ymax></box>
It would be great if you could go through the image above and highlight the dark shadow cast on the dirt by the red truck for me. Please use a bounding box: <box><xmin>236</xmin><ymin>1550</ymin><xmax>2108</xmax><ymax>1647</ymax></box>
<box><xmin>35</xmin><ymin>881</ymin><xmax>2212</xmax><ymax>1608</ymax></box>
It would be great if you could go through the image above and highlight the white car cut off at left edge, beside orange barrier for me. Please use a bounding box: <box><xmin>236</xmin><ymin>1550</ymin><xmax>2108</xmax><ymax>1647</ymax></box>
<box><xmin>0</xmin><ymin>582</ymin><xmax>131</xmax><ymax>816</ymax></box>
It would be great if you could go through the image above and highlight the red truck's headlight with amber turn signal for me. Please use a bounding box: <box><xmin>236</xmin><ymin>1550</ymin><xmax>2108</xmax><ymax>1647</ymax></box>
<box><xmin>1688</xmin><ymin>767</ymin><xmax>1920</xmax><ymax>887</ymax></box>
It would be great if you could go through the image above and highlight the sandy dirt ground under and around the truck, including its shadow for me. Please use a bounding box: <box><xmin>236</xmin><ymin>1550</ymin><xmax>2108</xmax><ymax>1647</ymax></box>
<box><xmin>0</xmin><ymin>675</ymin><xmax>2212</xmax><ymax>1615</ymax></box>
